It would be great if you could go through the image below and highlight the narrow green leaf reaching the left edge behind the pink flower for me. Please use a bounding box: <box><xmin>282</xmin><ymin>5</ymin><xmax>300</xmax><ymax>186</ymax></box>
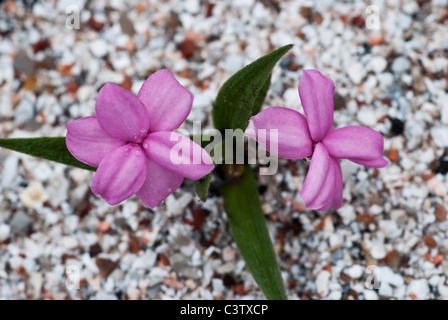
<box><xmin>0</xmin><ymin>137</ymin><xmax>96</xmax><ymax>171</ymax></box>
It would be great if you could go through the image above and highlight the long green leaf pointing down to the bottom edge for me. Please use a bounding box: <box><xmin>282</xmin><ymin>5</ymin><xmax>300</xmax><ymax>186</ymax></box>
<box><xmin>222</xmin><ymin>165</ymin><xmax>286</xmax><ymax>300</ymax></box>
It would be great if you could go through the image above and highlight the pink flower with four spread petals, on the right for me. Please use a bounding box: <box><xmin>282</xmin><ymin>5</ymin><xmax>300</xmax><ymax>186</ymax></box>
<box><xmin>246</xmin><ymin>70</ymin><xmax>388</xmax><ymax>211</ymax></box>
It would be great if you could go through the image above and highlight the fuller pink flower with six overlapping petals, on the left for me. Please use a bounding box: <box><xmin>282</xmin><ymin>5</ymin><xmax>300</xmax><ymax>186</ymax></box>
<box><xmin>66</xmin><ymin>70</ymin><xmax>214</xmax><ymax>208</ymax></box>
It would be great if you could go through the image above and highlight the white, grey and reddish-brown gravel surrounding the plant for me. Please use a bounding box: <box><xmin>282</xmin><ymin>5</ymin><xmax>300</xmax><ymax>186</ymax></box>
<box><xmin>0</xmin><ymin>0</ymin><xmax>448</xmax><ymax>299</ymax></box>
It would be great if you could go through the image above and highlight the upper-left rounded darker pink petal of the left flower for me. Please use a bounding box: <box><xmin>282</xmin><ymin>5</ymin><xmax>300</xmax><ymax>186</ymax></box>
<box><xmin>95</xmin><ymin>83</ymin><xmax>149</xmax><ymax>142</ymax></box>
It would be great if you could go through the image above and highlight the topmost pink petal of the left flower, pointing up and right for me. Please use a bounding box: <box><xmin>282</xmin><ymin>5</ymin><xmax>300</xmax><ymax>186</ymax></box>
<box><xmin>138</xmin><ymin>69</ymin><xmax>193</xmax><ymax>132</ymax></box>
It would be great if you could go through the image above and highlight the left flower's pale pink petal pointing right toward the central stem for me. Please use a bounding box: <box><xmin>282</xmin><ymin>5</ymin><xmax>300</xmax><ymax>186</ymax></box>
<box><xmin>143</xmin><ymin>131</ymin><xmax>215</xmax><ymax>180</ymax></box>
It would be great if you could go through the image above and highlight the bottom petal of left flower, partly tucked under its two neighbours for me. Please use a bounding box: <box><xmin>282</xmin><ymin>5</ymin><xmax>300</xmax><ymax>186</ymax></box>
<box><xmin>137</xmin><ymin>157</ymin><xmax>184</xmax><ymax>209</ymax></box>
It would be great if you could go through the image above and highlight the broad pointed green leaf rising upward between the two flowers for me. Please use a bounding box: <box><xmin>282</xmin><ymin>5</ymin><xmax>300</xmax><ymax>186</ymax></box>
<box><xmin>213</xmin><ymin>45</ymin><xmax>292</xmax><ymax>131</ymax></box>
